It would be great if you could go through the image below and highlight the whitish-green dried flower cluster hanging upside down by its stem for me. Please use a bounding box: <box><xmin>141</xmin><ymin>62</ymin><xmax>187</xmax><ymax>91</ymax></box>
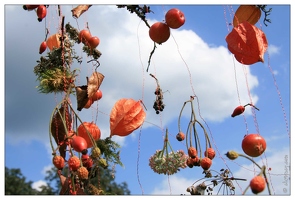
<box><xmin>149</xmin><ymin>150</ymin><xmax>188</xmax><ymax>175</ymax></box>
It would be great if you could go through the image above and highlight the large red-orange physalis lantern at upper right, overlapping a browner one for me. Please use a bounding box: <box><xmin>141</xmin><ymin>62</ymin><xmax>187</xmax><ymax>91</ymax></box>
<box><xmin>225</xmin><ymin>21</ymin><xmax>268</xmax><ymax>65</ymax></box>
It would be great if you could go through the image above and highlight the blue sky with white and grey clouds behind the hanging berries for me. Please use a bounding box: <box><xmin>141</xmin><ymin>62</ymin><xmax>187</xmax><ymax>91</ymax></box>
<box><xmin>4</xmin><ymin>1</ymin><xmax>291</xmax><ymax>195</ymax></box>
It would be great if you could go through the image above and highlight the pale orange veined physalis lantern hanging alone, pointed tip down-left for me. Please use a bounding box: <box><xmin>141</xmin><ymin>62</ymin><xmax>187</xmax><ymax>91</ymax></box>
<box><xmin>110</xmin><ymin>98</ymin><xmax>146</xmax><ymax>137</ymax></box>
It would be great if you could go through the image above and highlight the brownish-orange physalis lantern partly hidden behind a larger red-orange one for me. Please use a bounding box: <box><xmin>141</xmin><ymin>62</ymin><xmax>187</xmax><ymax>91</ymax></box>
<box><xmin>233</xmin><ymin>5</ymin><xmax>261</xmax><ymax>27</ymax></box>
